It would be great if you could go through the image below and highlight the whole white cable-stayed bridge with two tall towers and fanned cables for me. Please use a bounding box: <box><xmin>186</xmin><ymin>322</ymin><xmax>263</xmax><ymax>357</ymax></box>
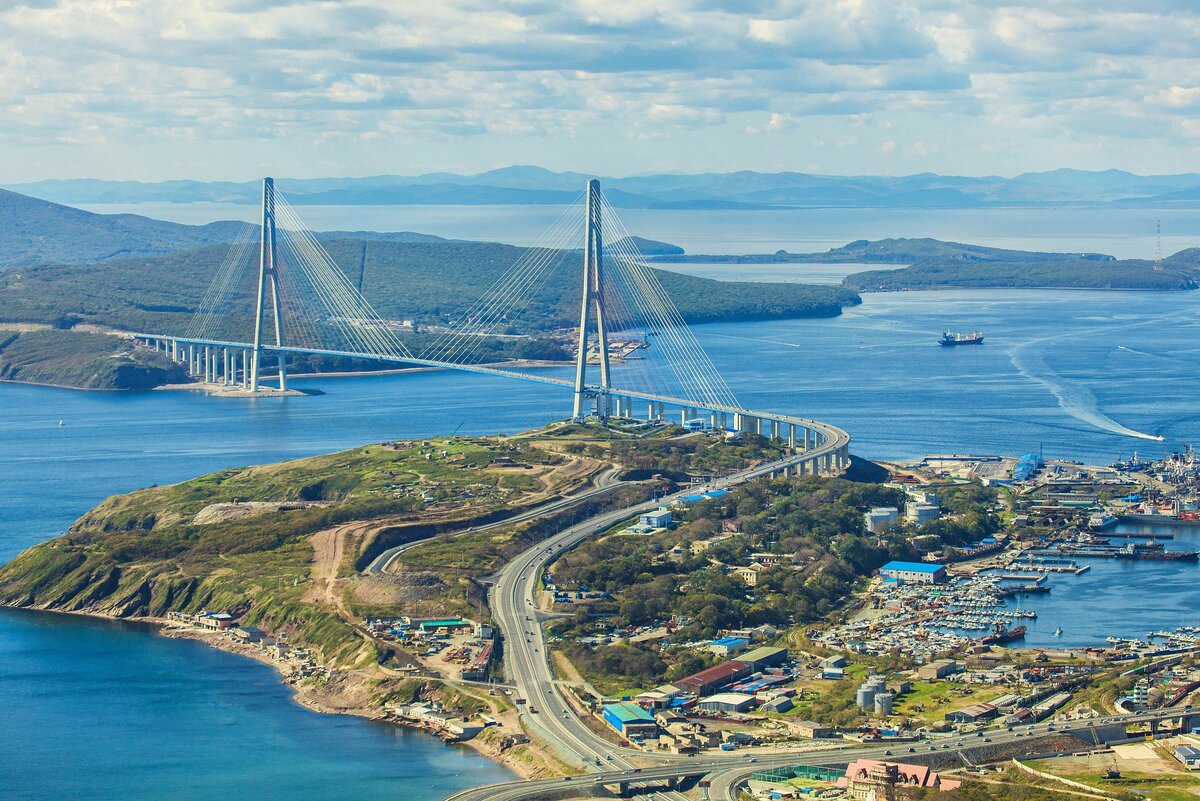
<box><xmin>134</xmin><ymin>179</ymin><xmax>850</xmax><ymax>474</ymax></box>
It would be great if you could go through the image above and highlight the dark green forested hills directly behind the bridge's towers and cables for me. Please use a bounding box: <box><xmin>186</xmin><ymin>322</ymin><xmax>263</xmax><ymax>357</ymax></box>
<box><xmin>0</xmin><ymin>239</ymin><xmax>859</xmax><ymax>333</ymax></box>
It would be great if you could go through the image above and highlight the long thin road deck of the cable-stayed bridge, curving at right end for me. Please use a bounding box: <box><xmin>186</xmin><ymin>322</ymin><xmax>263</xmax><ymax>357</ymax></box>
<box><xmin>130</xmin><ymin>333</ymin><xmax>850</xmax><ymax>472</ymax></box>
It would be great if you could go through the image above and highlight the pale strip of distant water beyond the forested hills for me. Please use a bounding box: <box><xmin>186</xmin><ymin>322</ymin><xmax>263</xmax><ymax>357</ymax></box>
<box><xmin>80</xmin><ymin>200</ymin><xmax>1200</xmax><ymax>259</ymax></box>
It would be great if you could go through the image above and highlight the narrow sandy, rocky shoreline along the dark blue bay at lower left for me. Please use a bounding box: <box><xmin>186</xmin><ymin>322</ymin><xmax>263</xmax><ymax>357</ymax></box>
<box><xmin>5</xmin><ymin>607</ymin><xmax>544</xmax><ymax>779</ymax></box>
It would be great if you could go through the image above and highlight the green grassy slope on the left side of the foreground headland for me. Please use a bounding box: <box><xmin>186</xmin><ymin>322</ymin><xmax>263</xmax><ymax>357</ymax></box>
<box><xmin>0</xmin><ymin>439</ymin><xmax>557</xmax><ymax>664</ymax></box>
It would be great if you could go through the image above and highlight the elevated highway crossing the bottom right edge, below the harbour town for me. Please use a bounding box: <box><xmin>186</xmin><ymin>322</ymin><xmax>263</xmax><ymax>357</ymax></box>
<box><xmin>446</xmin><ymin>707</ymin><xmax>1200</xmax><ymax>801</ymax></box>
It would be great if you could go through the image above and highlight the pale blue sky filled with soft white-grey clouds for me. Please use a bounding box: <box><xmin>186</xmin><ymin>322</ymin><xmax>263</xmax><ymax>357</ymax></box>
<box><xmin>0</xmin><ymin>0</ymin><xmax>1200</xmax><ymax>183</ymax></box>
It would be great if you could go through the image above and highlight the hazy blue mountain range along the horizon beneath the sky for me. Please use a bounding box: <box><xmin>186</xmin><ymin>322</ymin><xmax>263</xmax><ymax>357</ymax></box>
<box><xmin>7</xmin><ymin>167</ymin><xmax>1200</xmax><ymax>210</ymax></box>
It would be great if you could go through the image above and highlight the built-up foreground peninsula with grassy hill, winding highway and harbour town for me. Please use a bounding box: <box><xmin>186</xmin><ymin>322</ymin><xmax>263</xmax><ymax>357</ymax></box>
<box><xmin>0</xmin><ymin>418</ymin><xmax>1200</xmax><ymax>799</ymax></box>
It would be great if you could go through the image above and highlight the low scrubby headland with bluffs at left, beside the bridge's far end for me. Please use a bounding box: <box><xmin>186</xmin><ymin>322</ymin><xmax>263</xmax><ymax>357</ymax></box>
<box><xmin>0</xmin><ymin>330</ymin><xmax>191</xmax><ymax>390</ymax></box>
